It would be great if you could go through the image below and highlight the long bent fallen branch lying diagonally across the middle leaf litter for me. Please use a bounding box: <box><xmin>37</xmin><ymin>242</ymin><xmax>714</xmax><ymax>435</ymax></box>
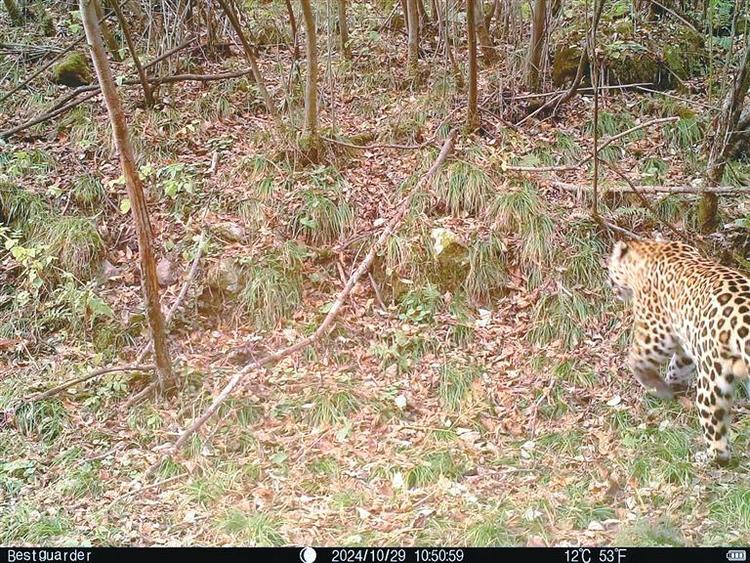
<box><xmin>142</xmin><ymin>130</ymin><xmax>457</xmax><ymax>475</ymax></box>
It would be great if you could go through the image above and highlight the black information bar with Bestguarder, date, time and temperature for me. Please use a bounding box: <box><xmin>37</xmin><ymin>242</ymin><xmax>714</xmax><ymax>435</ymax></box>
<box><xmin>0</xmin><ymin>547</ymin><xmax>750</xmax><ymax>563</ymax></box>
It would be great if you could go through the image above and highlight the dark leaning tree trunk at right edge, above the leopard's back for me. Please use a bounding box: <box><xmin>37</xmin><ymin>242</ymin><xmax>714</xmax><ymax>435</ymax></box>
<box><xmin>697</xmin><ymin>38</ymin><xmax>750</xmax><ymax>233</ymax></box>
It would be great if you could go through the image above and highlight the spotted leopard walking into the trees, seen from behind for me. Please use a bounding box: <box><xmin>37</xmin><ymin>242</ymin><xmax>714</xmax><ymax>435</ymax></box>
<box><xmin>608</xmin><ymin>239</ymin><xmax>750</xmax><ymax>466</ymax></box>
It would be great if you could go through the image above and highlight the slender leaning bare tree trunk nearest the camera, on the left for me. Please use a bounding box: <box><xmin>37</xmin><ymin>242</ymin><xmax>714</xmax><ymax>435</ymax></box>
<box><xmin>79</xmin><ymin>0</ymin><xmax>176</xmax><ymax>394</ymax></box>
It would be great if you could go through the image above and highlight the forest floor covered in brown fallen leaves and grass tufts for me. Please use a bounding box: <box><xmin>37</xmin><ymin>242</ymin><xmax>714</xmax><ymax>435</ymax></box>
<box><xmin>0</xmin><ymin>3</ymin><xmax>750</xmax><ymax>546</ymax></box>
